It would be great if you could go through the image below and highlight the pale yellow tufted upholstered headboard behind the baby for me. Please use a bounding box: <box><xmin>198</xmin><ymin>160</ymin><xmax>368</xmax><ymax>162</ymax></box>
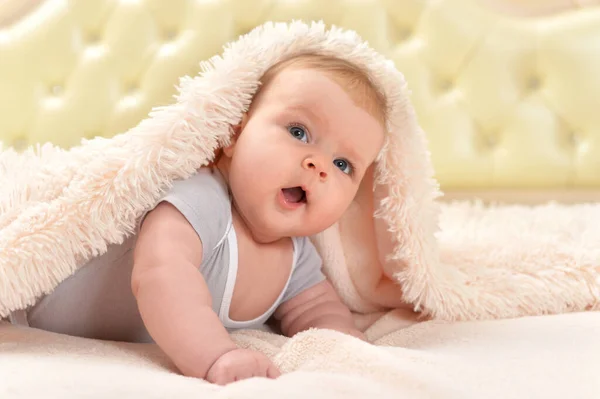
<box><xmin>0</xmin><ymin>0</ymin><xmax>600</xmax><ymax>190</ymax></box>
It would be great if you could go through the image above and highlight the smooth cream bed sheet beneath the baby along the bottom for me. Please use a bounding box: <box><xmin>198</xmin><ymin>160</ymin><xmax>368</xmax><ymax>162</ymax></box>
<box><xmin>0</xmin><ymin>311</ymin><xmax>600</xmax><ymax>399</ymax></box>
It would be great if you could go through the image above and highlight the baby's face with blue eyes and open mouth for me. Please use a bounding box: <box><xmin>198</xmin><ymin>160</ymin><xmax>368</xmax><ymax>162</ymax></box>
<box><xmin>226</xmin><ymin>68</ymin><xmax>384</xmax><ymax>242</ymax></box>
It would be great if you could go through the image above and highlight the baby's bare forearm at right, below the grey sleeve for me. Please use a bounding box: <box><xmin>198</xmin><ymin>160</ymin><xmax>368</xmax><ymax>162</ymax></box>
<box><xmin>274</xmin><ymin>280</ymin><xmax>365</xmax><ymax>340</ymax></box>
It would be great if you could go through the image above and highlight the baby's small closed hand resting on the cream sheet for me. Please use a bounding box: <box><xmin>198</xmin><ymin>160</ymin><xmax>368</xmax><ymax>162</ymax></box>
<box><xmin>206</xmin><ymin>349</ymin><xmax>281</xmax><ymax>385</ymax></box>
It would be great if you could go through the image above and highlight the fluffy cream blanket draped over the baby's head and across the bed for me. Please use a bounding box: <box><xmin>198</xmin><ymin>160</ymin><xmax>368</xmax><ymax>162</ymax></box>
<box><xmin>0</xmin><ymin>22</ymin><xmax>600</xmax><ymax>320</ymax></box>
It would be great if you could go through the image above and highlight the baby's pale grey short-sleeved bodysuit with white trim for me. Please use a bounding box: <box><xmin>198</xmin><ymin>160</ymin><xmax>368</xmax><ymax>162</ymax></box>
<box><xmin>19</xmin><ymin>168</ymin><xmax>325</xmax><ymax>342</ymax></box>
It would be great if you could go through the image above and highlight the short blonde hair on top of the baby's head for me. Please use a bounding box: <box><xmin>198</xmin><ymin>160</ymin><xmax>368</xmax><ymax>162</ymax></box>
<box><xmin>252</xmin><ymin>53</ymin><xmax>387</xmax><ymax>126</ymax></box>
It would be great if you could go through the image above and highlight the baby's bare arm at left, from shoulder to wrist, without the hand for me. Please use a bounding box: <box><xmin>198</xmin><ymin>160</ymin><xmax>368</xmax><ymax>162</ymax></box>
<box><xmin>131</xmin><ymin>202</ymin><xmax>236</xmax><ymax>378</ymax></box>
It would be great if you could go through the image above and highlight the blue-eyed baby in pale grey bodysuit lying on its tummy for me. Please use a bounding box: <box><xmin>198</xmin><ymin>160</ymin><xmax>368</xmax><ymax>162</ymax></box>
<box><xmin>16</xmin><ymin>54</ymin><xmax>386</xmax><ymax>384</ymax></box>
